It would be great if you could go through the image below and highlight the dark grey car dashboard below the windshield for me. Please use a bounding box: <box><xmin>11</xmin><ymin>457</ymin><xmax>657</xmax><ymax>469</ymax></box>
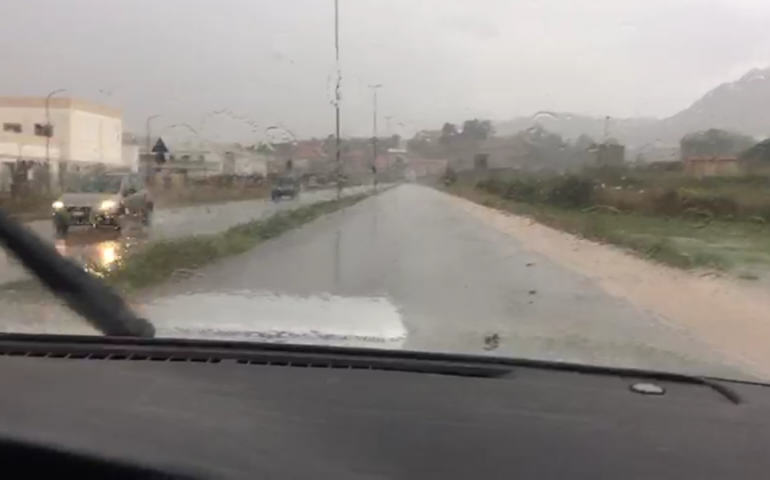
<box><xmin>0</xmin><ymin>336</ymin><xmax>770</xmax><ymax>480</ymax></box>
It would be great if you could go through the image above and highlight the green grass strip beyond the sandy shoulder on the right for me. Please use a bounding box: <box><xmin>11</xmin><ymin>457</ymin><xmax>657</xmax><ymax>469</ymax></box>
<box><xmin>448</xmin><ymin>186</ymin><xmax>770</xmax><ymax>280</ymax></box>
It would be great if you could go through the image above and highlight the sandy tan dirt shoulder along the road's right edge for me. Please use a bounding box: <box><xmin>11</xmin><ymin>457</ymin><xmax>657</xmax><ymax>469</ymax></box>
<box><xmin>449</xmin><ymin>196</ymin><xmax>770</xmax><ymax>379</ymax></box>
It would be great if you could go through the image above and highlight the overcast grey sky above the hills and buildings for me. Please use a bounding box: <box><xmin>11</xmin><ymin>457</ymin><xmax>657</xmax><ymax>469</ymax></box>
<box><xmin>0</xmin><ymin>0</ymin><xmax>770</xmax><ymax>142</ymax></box>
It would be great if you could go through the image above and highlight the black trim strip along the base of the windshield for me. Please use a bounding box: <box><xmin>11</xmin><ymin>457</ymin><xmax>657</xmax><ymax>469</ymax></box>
<box><xmin>0</xmin><ymin>333</ymin><xmax>752</xmax><ymax>405</ymax></box>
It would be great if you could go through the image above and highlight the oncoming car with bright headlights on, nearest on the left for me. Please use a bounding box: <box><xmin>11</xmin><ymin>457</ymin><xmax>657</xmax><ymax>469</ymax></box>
<box><xmin>52</xmin><ymin>173</ymin><xmax>154</xmax><ymax>237</ymax></box>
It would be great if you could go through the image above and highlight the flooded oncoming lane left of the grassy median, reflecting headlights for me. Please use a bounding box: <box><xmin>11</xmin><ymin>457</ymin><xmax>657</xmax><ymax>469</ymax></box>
<box><xmin>0</xmin><ymin>187</ymin><xmax>369</xmax><ymax>284</ymax></box>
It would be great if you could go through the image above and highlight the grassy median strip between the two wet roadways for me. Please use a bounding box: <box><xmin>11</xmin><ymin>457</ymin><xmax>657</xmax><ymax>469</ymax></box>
<box><xmin>88</xmin><ymin>194</ymin><xmax>368</xmax><ymax>291</ymax></box>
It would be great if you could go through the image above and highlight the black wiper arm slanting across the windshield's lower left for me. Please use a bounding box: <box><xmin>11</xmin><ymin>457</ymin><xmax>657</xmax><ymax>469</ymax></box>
<box><xmin>0</xmin><ymin>209</ymin><xmax>155</xmax><ymax>337</ymax></box>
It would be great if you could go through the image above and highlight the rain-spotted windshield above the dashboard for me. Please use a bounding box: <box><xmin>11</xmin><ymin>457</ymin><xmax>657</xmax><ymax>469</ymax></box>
<box><xmin>0</xmin><ymin>0</ymin><xmax>770</xmax><ymax>381</ymax></box>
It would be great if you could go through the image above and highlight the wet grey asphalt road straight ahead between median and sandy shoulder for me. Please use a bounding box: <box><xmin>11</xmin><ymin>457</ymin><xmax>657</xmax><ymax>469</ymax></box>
<box><xmin>0</xmin><ymin>185</ymin><xmax>748</xmax><ymax>378</ymax></box>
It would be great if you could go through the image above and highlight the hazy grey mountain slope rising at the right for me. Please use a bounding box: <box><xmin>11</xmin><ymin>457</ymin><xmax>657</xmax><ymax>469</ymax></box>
<box><xmin>495</xmin><ymin>68</ymin><xmax>770</xmax><ymax>148</ymax></box>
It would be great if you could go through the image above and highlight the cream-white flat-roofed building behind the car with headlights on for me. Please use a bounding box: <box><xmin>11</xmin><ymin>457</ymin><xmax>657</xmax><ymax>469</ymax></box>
<box><xmin>0</xmin><ymin>97</ymin><xmax>129</xmax><ymax>189</ymax></box>
